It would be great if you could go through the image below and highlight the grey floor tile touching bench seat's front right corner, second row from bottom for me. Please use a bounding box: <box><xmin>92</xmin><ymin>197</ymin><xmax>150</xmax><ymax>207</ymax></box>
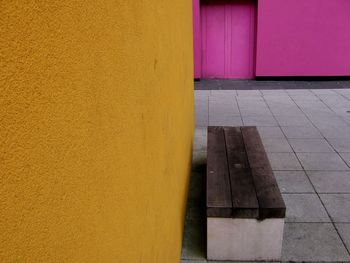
<box><xmin>283</xmin><ymin>194</ymin><xmax>330</xmax><ymax>223</ymax></box>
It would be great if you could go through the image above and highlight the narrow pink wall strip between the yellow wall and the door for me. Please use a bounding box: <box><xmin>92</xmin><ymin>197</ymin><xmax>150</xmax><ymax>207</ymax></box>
<box><xmin>193</xmin><ymin>0</ymin><xmax>202</xmax><ymax>79</ymax></box>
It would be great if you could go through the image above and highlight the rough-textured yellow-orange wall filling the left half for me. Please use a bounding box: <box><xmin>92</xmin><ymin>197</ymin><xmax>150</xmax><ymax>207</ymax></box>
<box><xmin>0</xmin><ymin>0</ymin><xmax>193</xmax><ymax>263</ymax></box>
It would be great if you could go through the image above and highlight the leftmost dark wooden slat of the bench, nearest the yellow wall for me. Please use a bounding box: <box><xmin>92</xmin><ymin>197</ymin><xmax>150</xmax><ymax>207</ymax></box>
<box><xmin>207</xmin><ymin>127</ymin><xmax>232</xmax><ymax>217</ymax></box>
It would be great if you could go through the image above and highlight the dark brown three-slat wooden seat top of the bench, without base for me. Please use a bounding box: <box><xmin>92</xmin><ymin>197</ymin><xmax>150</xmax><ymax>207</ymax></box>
<box><xmin>207</xmin><ymin>126</ymin><xmax>286</xmax><ymax>220</ymax></box>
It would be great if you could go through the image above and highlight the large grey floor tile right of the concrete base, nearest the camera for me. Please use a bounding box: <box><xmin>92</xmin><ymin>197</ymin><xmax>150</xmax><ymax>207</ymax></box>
<box><xmin>282</xmin><ymin>223</ymin><xmax>350</xmax><ymax>262</ymax></box>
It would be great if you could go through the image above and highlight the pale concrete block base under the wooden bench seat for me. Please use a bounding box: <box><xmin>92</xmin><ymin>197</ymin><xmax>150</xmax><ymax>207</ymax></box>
<box><xmin>207</xmin><ymin>217</ymin><xmax>284</xmax><ymax>261</ymax></box>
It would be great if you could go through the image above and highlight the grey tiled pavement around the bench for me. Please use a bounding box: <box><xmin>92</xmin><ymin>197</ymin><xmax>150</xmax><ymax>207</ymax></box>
<box><xmin>182</xmin><ymin>81</ymin><xmax>350</xmax><ymax>263</ymax></box>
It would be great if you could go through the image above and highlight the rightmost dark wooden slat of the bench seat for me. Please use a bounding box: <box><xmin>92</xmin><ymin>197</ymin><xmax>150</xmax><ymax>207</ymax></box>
<box><xmin>241</xmin><ymin>127</ymin><xmax>286</xmax><ymax>219</ymax></box>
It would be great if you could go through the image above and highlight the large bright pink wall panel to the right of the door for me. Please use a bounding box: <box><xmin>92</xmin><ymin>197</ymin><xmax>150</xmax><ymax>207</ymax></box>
<box><xmin>256</xmin><ymin>0</ymin><xmax>350</xmax><ymax>76</ymax></box>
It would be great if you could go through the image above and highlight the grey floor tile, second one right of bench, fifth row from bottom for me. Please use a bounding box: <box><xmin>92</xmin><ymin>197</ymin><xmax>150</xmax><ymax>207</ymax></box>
<box><xmin>288</xmin><ymin>139</ymin><xmax>334</xmax><ymax>153</ymax></box>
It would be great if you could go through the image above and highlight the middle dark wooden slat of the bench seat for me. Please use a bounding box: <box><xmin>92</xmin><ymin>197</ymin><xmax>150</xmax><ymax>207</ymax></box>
<box><xmin>224</xmin><ymin>127</ymin><xmax>259</xmax><ymax>218</ymax></box>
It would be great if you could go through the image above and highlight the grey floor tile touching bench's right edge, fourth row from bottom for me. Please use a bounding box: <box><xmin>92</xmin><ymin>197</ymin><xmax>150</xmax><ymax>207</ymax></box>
<box><xmin>267</xmin><ymin>153</ymin><xmax>302</xmax><ymax>171</ymax></box>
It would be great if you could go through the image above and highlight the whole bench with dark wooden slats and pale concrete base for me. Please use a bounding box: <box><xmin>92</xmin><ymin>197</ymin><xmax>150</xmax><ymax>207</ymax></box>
<box><xmin>207</xmin><ymin>127</ymin><xmax>286</xmax><ymax>261</ymax></box>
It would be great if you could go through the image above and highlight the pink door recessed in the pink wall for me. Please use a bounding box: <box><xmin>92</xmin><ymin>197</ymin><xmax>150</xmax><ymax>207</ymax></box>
<box><xmin>201</xmin><ymin>0</ymin><xmax>256</xmax><ymax>79</ymax></box>
